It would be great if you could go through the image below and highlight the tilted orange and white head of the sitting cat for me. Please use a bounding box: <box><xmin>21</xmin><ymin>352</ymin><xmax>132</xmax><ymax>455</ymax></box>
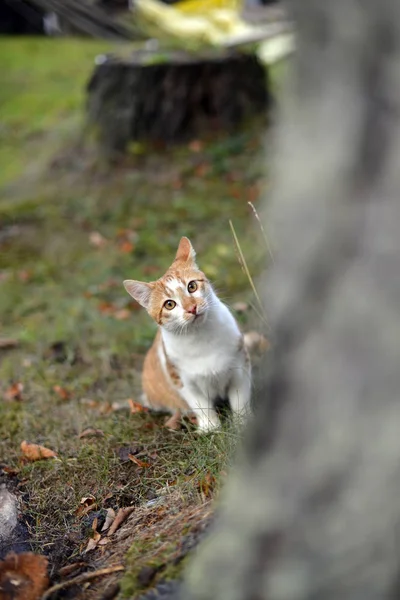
<box><xmin>124</xmin><ymin>237</ymin><xmax>213</xmax><ymax>333</ymax></box>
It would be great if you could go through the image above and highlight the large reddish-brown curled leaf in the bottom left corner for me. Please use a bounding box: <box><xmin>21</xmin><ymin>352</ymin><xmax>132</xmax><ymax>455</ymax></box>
<box><xmin>0</xmin><ymin>552</ymin><xmax>49</xmax><ymax>600</ymax></box>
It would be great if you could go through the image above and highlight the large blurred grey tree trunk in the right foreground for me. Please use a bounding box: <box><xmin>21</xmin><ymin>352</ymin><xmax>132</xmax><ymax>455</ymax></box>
<box><xmin>175</xmin><ymin>0</ymin><xmax>400</xmax><ymax>600</ymax></box>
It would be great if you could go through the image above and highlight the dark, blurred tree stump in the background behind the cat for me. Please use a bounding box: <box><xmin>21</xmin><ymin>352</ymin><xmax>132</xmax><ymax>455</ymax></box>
<box><xmin>88</xmin><ymin>50</ymin><xmax>270</xmax><ymax>153</ymax></box>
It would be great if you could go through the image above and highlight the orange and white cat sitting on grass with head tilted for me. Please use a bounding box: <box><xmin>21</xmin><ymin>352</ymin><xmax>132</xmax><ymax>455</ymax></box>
<box><xmin>124</xmin><ymin>237</ymin><xmax>251</xmax><ymax>432</ymax></box>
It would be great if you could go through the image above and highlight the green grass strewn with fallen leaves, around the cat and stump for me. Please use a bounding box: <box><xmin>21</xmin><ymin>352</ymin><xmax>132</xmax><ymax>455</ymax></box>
<box><xmin>0</xmin><ymin>39</ymin><xmax>272</xmax><ymax>589</ymax></box>
